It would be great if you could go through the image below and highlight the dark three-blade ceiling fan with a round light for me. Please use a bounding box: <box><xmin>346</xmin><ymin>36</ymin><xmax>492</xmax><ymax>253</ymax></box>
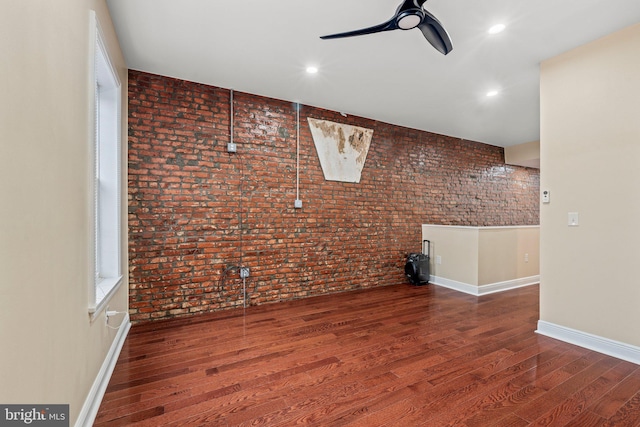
<box><xmin>320</xmin><ymin>0</ymin><xmax>453</xmax><ymax>55</ymax></box>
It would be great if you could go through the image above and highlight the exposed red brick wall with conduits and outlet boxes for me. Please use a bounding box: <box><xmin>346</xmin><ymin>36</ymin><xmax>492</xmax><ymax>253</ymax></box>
<box><xmin>129</xmin><ymin>71</ymin><xmax>539</xmax><ymax>321</ymax></box>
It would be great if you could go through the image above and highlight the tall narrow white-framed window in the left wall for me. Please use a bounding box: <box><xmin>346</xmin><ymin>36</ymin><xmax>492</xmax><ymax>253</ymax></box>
<box><xmin>89</xmin><ymin>14</ymin><xmax>122</xmax><ymax>313</ymax></box>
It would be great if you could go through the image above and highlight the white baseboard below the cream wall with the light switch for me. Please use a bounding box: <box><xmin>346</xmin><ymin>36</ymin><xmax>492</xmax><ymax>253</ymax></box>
<box><xmin>536</xmin><ymin>320</ymin><xmax>640</xmax><ymax>365</ymax></box>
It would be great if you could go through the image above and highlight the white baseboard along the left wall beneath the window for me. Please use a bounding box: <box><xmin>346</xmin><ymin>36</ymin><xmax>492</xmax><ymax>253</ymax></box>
<box><xmin>75</xmin><ymin>313</ymin><xmax>131</xmax><ymax>427</ymax></box>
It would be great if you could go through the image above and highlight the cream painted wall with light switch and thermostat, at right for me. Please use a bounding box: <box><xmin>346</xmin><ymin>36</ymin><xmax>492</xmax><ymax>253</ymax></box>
<box><xmin>540</xmin><ymin>24</ymin><xmax>640</xmax><ymax>346</ymax></box>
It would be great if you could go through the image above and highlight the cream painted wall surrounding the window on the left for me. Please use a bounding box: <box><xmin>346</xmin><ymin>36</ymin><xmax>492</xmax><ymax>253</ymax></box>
<box><xmin>0</xmin><ymin>0</ymin><xmax>128</xmax><ymax>425</ymax></box>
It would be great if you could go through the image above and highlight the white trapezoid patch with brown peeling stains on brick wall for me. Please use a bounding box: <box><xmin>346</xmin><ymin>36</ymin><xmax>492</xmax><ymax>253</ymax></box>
<box><xmin>308</xmin><ymin>118</ymin><xmax>373</xmax><ymax>183</ymax></box>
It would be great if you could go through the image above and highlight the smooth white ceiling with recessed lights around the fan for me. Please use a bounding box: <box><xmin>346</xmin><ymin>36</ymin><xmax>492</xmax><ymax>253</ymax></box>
<box><xmin>107</xmin><ymin>0</ymin><xmax>640</xmax><ymax>147</ymax></box>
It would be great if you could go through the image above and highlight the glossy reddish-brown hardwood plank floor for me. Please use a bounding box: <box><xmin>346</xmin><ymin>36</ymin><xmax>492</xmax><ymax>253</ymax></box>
<box><xmin>95</xmin><ymin>285</ymin><xmax>640</xmax><ymax>427</ymax></box>
